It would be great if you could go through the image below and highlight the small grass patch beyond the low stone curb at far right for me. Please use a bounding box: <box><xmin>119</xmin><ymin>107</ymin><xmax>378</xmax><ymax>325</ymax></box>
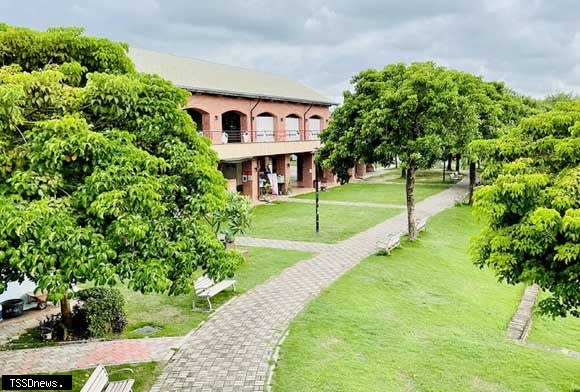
<box><xmin>528</xmin><ymin>293</ymin><xmax>580</xmax><ymax>352</ymax></box>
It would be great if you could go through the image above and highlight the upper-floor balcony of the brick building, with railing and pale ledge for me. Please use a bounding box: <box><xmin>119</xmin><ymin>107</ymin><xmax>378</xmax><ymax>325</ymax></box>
<box><xmin>203</xmin><ymin>130</ymin><xmax>320</xmax><ymax>160</ymax></box>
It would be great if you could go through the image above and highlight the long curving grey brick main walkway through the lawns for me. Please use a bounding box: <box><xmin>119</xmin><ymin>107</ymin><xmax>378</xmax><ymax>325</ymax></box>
<box><xmin>152</xmin><ymin>181</ymin><xmax>466</xmax><ymax>392</ymax></box>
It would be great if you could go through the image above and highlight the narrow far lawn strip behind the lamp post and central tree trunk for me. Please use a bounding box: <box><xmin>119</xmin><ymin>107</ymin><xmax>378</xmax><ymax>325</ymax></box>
<box><xmin>296</xmin><ymin>183</ymin><xmax>449</xmax><ymax>206</ymax></box>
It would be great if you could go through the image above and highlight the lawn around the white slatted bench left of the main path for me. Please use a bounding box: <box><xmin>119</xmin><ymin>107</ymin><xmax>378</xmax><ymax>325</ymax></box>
<box><xmin>116</xmin><ymin>247</ymin><xmax>312</xmax><ymax>338</ymax></box>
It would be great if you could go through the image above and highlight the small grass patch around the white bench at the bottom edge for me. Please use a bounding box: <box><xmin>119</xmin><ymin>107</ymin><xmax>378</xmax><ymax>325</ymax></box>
<box><xmin>14</xmin><ymin>362</ymin><xmax>161</xmax><ymax>392</ymax></box>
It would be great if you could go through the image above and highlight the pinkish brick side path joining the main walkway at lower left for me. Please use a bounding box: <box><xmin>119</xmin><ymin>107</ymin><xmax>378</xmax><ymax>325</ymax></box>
<box><xmin>0</xmin><ymin>337</ymin><xmax>183</xmax><ymax>374</ymax></box>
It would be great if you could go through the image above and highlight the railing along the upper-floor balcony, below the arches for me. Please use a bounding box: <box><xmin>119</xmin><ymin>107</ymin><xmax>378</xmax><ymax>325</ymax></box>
<box><xmin>198</xmin><ymin>129</ymin><xmax>319</xmax><ymax>144</ymax></box>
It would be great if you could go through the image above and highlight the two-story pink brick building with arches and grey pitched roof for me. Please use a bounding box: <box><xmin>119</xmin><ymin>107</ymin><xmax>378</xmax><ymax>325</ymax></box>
<box><xmin>130</xmin><ymin>49</ymin><xmax>335</xmax><ymax>200</ymax></box>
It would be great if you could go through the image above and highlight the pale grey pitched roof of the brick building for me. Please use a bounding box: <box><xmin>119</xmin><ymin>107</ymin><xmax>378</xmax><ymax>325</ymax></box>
<box><xmin>129</xmin><ymin>48</ymin><xmax>335</xmax><ymax>105</ymax></box>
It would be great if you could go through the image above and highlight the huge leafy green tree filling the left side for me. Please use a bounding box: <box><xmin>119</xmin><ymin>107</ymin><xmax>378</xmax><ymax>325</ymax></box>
<box><xmin>0</xmin><ymin>25</ymin><xmax>241</xmax><ymax>323</ymax></box>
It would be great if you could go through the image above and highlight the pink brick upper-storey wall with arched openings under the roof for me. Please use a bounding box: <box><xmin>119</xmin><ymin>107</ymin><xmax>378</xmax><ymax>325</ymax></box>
<box><xmin>186</xmin><ymin>93</ymin><xmax>330</xmax><ymax>144</ymax></box>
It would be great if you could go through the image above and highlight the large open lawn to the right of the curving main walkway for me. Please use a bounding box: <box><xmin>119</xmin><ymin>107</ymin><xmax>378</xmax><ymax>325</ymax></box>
<box><xmin>274</xmin><ymin>207</ymin><xmax>580</xmax><ymax>392</ymax></box>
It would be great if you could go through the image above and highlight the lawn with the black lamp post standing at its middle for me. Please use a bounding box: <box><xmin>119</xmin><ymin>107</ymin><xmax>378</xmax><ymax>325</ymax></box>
<box><xmin>248</xmin><ymin>202</ymin><xmax>403</xmax><ymax>243</ymax></box>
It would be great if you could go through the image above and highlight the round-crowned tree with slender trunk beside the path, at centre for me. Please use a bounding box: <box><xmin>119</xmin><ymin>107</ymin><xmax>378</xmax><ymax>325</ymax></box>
<box><xmin>320</xmin><ymin>62</ymin><xmax>478</xmax><ymax>240</ymax></box>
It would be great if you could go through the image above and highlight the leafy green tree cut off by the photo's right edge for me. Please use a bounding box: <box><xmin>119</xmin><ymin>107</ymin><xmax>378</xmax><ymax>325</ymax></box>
<box><xmin>472</xmin><ymin>101</ymin><xmax>580</xmax><ymax>316</ymax></box>
